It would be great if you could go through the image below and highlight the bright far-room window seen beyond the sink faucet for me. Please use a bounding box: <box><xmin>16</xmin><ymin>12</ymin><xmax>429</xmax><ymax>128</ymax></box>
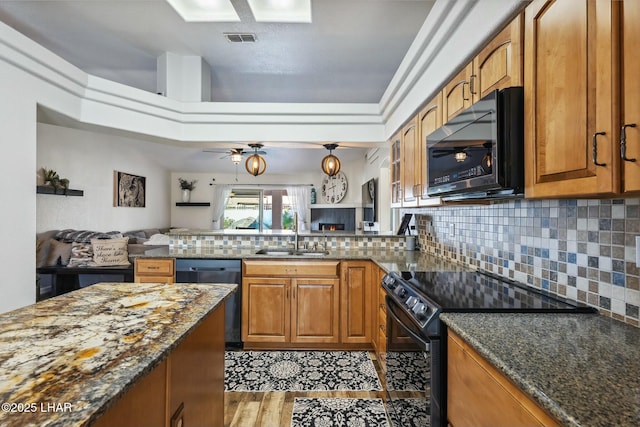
<box><xmin>224</xmin><ymin>188</ymin><xmax>293</xmax><ymax>231</ymax></box>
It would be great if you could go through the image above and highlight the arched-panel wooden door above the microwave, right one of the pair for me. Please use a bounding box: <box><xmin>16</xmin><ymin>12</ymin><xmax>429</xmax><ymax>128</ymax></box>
<box><xmin>471</xmin><ymin>15</ymin><xmax>523</xmax><ymax>102</ymax></box>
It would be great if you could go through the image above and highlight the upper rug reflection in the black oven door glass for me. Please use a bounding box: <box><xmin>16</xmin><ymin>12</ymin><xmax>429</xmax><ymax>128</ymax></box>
<box><xmin>386</xmin><ymin>351</ymin><xmax>431</xmax><ymax>391</ymax></box>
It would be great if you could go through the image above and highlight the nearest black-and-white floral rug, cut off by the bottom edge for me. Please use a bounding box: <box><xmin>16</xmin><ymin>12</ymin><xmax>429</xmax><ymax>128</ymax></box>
<box><xmin>291</xmin><ymin>397</ymin><xmax>389</xmax><ymax>427</ymax></box>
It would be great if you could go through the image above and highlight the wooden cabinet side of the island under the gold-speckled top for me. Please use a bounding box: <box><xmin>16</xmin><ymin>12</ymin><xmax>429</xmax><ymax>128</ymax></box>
<box><xmin>93</xmin><ymin>305</ymin><xmax>224</xmax><ymax>427</ymax></box>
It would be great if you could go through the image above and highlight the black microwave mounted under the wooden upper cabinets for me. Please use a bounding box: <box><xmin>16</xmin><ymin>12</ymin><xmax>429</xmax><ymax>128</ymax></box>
<box><xmin>426</xmin><ymin>87</ymin><xmax>524</xmax><ymax>200</ymax></box>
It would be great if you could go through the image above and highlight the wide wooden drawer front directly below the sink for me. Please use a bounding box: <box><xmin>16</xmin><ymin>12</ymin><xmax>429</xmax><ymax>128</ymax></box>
<box><xmin>242</xmin><ymin>260</ymin><xmax>340</xmax><ymax>277</ymax></box>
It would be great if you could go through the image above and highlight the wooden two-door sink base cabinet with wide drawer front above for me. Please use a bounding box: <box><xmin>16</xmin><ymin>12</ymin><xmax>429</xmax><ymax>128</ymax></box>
<box><xmin>242</xmin><ymin>260</ymin><xmax>340</xmax><ymax>348</ymax></box>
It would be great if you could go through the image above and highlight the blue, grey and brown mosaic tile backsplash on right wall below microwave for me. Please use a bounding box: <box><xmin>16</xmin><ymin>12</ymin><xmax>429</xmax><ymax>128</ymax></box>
<box><xmin>406</xmin><ymin>198</ymin><xmax>640</xmax><ymax>327</ymax></box>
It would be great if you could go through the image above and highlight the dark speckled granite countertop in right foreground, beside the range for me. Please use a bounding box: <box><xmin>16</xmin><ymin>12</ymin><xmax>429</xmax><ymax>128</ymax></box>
<box><xmin>440</xmin><ymin>313</ymin><xmax>640</xmax><ymax>427</ymax></box>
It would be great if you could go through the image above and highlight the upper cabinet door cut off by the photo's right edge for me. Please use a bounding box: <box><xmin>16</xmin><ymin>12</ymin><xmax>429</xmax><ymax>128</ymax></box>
<box><xmin>619</xmin><ymin>1</ymin><xmax>640</xmax><ymax>192</ymax></box>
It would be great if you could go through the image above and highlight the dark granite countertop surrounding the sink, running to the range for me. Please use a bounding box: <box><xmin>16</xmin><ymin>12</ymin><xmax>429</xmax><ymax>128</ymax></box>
<box><xmin>130</xmin><ymin>246</ymin><xmax>471</xmax><ymax>271</ymax></box>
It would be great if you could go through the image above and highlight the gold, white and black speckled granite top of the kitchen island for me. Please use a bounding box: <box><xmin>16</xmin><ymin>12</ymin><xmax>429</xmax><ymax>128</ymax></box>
<box><xmin>0</xmin><ymin>283</ymin><xmax>236</xmax><ymax>427</ymax></box>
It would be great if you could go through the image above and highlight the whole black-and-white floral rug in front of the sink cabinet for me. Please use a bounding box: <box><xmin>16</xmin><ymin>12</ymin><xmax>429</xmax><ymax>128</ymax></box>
<box><xmin>224</xmin><ymin>351</ymin><xmax>382</xmax><ymax>392</ymax></box>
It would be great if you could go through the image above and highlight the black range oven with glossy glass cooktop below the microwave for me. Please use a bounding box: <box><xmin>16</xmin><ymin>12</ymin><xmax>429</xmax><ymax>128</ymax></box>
<box><xmin>381</xmin><ymin>271</ymin><xmax>594</xmax><ymax>427</ymax></box>
